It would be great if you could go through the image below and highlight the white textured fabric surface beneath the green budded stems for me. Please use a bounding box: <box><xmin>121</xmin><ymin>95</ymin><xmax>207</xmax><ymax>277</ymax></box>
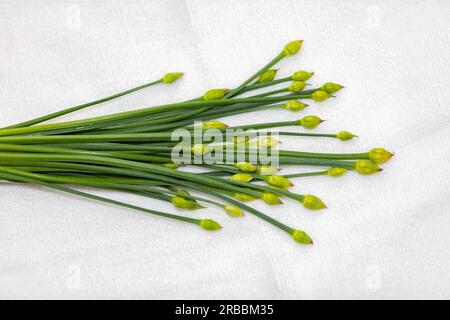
<box><xmin>0</xmin><ymin>0</ymin><xmax>450</xmax><ymax>299</ymax></box>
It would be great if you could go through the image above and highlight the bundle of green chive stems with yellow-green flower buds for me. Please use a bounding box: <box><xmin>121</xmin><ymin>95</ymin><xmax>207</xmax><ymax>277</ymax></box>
<box><xmin>0</xmin><ymin>40</ymin><xmax>393</xmax><ymax>244</ymax></box>
